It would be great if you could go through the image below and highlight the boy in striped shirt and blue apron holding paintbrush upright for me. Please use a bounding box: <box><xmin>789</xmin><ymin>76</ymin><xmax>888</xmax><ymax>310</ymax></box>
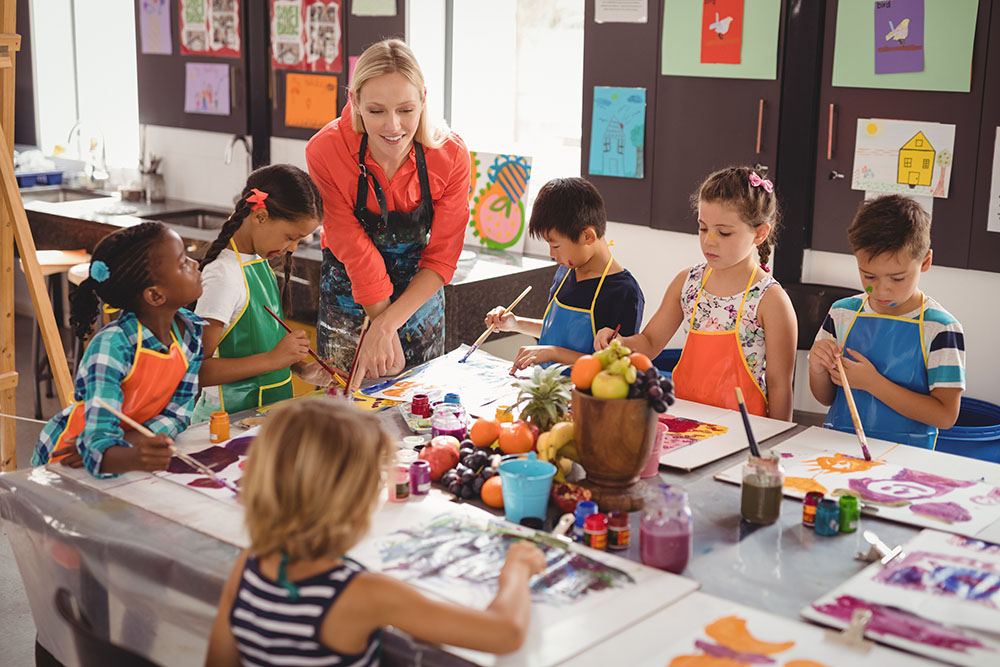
<box><xmin>809</xmin><ymin>195</ymin><xmax>965</xmax><ymax>449</ymax></box>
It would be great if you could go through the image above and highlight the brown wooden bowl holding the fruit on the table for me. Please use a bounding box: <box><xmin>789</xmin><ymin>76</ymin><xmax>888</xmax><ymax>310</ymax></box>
<box><xmin>573</xmin><ymin>389</ymin><xmax>657</xmax><ymax>511</ymax></box>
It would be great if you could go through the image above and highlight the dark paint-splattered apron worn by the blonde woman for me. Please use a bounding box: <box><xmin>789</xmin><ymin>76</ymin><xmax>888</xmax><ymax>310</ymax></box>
<box><xmin>316</xmin><ymin>134</ymin><xmax>444</xmax><ymax>368</ymax></box>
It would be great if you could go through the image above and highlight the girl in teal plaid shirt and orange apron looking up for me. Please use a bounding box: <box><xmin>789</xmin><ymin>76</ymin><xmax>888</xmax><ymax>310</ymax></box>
<box><xmin>31</xmin><ymin>222</ymin><xmax>204</xmax><ymax>477</ymax></box>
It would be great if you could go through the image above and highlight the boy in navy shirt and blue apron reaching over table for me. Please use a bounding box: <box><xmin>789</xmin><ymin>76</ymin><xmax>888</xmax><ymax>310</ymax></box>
<box><xmin>486</xmin><ymin>178</ymin><xmax>644</xmax><ymax>371</ymax></box>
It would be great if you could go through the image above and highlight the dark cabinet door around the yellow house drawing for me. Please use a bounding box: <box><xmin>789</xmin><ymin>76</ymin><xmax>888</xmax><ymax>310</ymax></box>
<box><xmin>811</xmin><ymin>0</ymin><xmax>990</xmax><ymax>268</ymax></box>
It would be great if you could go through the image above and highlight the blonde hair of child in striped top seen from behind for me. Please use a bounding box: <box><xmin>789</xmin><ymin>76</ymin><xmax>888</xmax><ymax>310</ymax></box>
<box><xmin>240</xmin><ymin>398</ymin><xmax>392</xmax><ymax>560</ymax></box>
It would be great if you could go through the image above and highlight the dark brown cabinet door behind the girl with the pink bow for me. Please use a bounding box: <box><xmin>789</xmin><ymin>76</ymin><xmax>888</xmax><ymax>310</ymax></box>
<box><xmin>652</xmin><ymin>2</ymin><xmax>787</xmax><ymax>233</ymax></box>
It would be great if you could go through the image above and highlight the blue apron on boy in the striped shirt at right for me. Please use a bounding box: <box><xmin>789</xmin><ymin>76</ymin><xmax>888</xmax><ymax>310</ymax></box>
<box><xmin>823</xmin><ymin>295</ymin><xmax>938</xmax><ymax>449</ymax></box>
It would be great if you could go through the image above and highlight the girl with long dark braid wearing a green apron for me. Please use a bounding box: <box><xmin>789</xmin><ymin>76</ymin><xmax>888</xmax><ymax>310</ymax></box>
<box><xmin>192</xmin><ymin>164</ymin><xmax>331</xmax><ymax>422</ymax></box>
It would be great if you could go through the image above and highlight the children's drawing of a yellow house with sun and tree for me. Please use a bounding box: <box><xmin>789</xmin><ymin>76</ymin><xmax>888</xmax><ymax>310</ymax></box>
<box><xmin>851</xmin><ymin>118</ymin><xmax>955</xmax><ymax>198</ymax></box>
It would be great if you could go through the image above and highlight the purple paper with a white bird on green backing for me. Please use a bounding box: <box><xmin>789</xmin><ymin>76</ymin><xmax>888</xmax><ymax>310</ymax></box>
<box><xmin>875</xmin><ymin>0</ymin><xmax>924</xmax><ymax>74</ymax></box>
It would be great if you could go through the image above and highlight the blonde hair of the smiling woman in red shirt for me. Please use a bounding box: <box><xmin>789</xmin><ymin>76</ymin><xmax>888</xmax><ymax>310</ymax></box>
<box><xmin>351</xmin><ymin>39</ymin><xmax>448</xmax><ymax>148</ymax></box>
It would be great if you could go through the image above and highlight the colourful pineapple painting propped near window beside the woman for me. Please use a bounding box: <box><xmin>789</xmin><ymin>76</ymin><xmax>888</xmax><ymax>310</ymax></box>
<box><xmin>465</xmin><ymin>151</ymin><xmax>531</xmax><ymax>252</ymax></box>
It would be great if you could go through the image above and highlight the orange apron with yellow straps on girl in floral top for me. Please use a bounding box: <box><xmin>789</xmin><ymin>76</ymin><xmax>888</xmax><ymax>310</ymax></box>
<box><xmin>673</xmin><ymin>267</ymin><xmax>767</xmax><ymax>417</ymax></box>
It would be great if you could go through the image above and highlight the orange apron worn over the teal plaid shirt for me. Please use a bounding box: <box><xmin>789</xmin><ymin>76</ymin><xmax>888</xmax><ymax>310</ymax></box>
<box><xmin>52</xmin><ymin>320</ymin><xmax>188</xmax><ymax>460</ymax></box>
